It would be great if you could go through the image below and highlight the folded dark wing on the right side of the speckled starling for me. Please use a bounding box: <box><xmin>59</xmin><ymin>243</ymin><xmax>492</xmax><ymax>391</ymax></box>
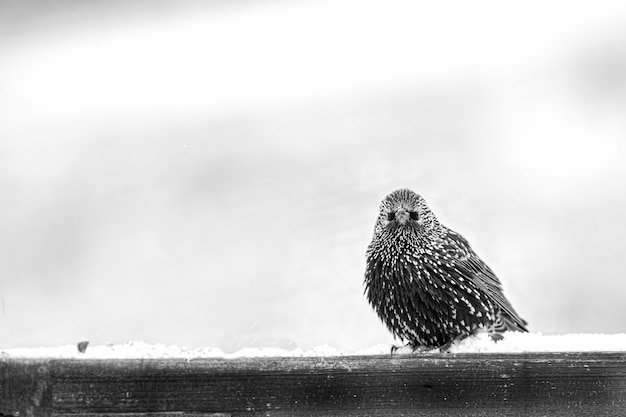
<box><xmin>438</xmin><ymin>229</ymin><xmax>528</xmax><ymax>331</ymax></box>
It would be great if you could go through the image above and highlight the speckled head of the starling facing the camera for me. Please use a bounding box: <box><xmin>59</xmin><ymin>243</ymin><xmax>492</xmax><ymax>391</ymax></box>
<box><xmin>374</xmin><ymin>188</ymin><xmax>439</xmax><ymax>235</ymax></box>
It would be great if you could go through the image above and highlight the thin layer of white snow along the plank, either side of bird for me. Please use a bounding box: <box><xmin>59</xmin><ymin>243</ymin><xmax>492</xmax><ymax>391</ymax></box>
<box><xmin>0</xmin><ymin>332</ymin><xmax>626</xmax><ymax>359</ymax></box>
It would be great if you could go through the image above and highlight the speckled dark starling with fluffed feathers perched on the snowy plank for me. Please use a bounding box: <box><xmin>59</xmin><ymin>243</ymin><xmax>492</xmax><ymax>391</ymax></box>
<box><xmin>365</xmin><ymin>188</ymin><xmax>528</xmax><ymax>350</ymax></box>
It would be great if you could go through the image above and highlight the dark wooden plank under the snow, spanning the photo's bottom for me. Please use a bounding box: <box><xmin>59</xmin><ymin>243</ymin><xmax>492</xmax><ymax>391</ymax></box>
<box><xmin>0</xmin><ymin>352</ymin><xmax>626</xmax><ymax>417</ymax></box>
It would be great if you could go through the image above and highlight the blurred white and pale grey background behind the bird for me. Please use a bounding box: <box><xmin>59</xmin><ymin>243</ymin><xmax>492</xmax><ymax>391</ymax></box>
<box><xmin>0</xmin><ymin>0</ymin><xmax>626</xmax><ymax>351</ymax></box>
